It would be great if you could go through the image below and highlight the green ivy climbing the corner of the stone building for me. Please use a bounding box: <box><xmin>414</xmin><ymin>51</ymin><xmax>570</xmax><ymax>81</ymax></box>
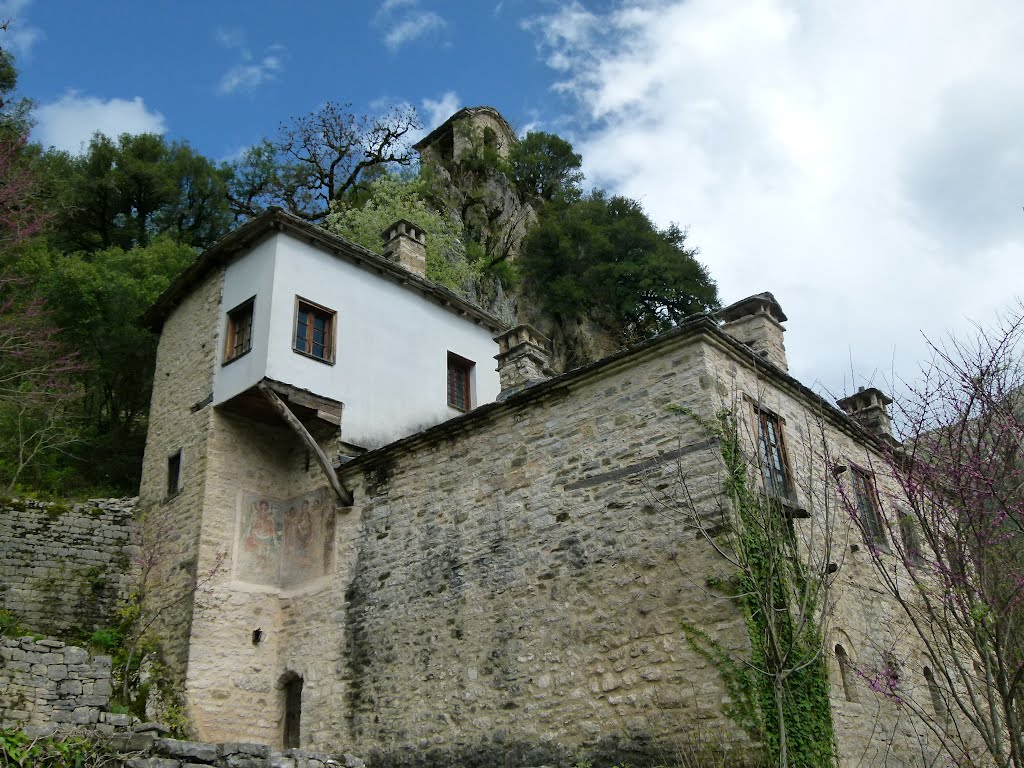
<box><xmin>673</xmin><ymin>408</ymin><xmax>835</xmax><ymax>768</ymax></box>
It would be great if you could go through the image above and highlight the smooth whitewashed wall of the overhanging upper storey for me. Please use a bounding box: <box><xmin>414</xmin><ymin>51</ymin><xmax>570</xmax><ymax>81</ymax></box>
<box><xmin>214</xmin><ymin>233</ymin><xmax>500</xmax><ymax>447</ymax></box>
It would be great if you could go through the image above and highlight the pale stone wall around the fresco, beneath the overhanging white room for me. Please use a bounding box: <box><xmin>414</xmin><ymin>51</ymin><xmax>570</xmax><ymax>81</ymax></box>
<box><xmin>187</xmin><ymin>412</ymin><xmax>345</xmax><ymax>748</ymax></box>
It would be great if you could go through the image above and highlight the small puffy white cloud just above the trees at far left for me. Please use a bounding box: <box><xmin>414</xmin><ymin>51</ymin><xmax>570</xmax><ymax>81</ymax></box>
<box><xmin>32</xmin><ymin>91</ymin><xmax>167</xmax><ymax>153</ymax></box>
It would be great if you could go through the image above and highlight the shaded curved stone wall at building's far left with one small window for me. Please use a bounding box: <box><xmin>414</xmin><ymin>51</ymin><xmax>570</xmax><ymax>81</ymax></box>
<box><xmin>139</xmin><ymin>270</ymin><xmax>223</xmax><ymax>683</ymax></box>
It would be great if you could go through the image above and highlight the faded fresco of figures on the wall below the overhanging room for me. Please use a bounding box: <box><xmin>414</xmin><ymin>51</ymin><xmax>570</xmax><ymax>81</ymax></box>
<box><xmin>234</xmin><ymin>490</ymin><xmax>334</xmax><ymax>589</ymax></box>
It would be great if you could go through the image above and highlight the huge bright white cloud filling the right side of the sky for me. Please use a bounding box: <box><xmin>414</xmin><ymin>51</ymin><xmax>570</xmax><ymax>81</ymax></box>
<box><xmin>529</xmin><ymin>0</ymin><xmax>1024</xmax><ymax>403</ymax></box>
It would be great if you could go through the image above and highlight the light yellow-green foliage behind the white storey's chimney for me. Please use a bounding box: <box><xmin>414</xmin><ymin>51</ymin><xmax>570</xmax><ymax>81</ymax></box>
<box><xmin>324</xmin><ymin>174</ymin><xmax>479</xmax><ymax>291</ymax></box>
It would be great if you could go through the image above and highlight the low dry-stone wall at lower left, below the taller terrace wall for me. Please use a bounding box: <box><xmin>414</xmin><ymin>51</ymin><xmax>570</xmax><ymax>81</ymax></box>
<box><xmin>0</xmin><ymin>637</ymin><xmax>111</xmax><ymax>728</ymax></box>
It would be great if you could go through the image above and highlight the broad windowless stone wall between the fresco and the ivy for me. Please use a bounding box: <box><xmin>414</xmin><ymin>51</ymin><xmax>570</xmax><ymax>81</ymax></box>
<box><xmin>331</xmin><ymin>339</ymin><xmax>748</xmax><ymax>766</ymax></box>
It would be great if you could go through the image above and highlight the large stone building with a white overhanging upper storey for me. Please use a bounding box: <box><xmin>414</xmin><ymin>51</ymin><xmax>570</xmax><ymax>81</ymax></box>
<box><xmin>140</xmin><ymin>191</ymin><xmax>942</xmax><ymax>765</ymax></box>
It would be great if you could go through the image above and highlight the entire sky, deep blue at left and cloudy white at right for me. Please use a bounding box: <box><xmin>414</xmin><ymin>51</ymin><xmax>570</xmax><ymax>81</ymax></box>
<box><xmin>0</xmin><ymin>0</ymin><xmax>1024</xmax><ymax>394</ymax></box>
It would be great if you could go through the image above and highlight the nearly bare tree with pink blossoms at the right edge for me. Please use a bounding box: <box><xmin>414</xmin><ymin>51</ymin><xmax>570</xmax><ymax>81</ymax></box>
<box><xmin>842</xmin><ymin>305</ymin><xmax>1024</xmax><ymax>768</ymax></box>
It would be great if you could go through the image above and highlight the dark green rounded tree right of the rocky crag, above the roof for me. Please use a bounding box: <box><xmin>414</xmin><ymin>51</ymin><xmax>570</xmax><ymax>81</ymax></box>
<box><xmin>518</xmin><ymin>191</ymin><xmax>718</xmax><ymax>343</ymax></box>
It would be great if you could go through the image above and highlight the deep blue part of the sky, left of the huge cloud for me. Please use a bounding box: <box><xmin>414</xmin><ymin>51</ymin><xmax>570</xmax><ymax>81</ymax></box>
<box><xmin>8</xmin><ymin>0</ymin><xmax>560</xmax><ymax>159</ymax></box>
